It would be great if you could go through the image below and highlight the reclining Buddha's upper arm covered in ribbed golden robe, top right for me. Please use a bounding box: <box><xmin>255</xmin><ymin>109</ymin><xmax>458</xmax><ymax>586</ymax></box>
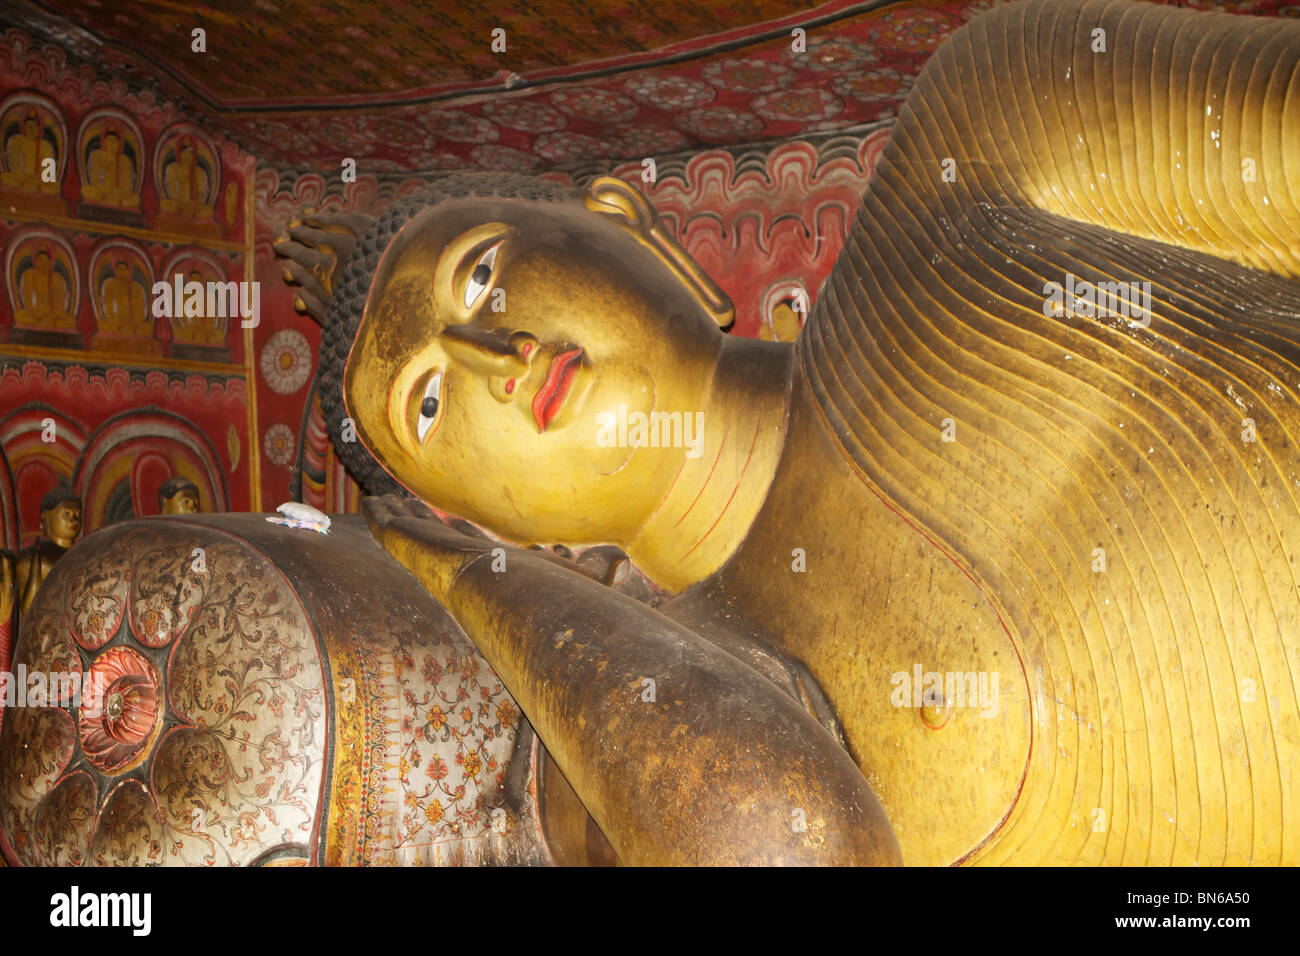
<box><xmin>899</xmin><ymin>0</ymin><xmax>1300</xmax><ymax>277</ymax></box>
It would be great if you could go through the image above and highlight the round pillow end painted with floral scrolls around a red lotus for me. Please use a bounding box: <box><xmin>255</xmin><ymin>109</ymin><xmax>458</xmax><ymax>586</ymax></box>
<box><xmin>0</xmin><ymin>520</ymin><xmax>325</xmax><ymax>865</ymax></box>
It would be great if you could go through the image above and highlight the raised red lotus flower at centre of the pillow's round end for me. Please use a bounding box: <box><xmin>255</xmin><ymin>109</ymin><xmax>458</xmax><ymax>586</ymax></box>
<box><xmin>77</xmin><ymin>646</ymin><xmax>161</xmax><ymax>774</ymax></box>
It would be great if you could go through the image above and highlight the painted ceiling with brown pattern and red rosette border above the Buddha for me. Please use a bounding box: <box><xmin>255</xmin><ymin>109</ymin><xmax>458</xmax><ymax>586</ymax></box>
<box><xmin>16</xmin><ymin>0</ymin><xmax>1300</xmax><ymax>173</ymax></box>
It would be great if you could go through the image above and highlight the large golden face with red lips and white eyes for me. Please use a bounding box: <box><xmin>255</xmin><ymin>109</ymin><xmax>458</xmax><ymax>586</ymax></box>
<box><xmin>345</xmin><ymin>199</ymin><xmax>723</xmax><ymax>542</ymax></box>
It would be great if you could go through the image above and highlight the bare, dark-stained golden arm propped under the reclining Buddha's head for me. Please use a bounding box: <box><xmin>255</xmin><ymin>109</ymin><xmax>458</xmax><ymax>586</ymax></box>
<box><xmin>365</xmin><ymin>498</ymin><xmax>898</xmax><ymax>865</ymax></box>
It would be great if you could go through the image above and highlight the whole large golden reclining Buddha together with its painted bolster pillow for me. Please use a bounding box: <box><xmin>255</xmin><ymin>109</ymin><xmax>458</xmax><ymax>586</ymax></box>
<box><xmin>0</xmin><ymin>0</ymin><xmax>1300</xmax><ymax>865</ymax></box>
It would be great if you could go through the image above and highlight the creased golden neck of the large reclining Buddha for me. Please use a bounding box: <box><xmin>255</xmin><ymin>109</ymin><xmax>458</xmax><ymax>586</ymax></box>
<box><xmin>627</xmin><ymin>338</ymin><xmax>793</xmax><ymax>591</ymax></box>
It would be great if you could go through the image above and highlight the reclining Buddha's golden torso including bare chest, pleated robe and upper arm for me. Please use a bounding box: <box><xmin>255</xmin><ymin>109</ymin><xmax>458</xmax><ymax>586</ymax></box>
<box><xmin>670</xmin><ymin>3</ymin><xmax>1300</xmax><ymax>865</ymax></box>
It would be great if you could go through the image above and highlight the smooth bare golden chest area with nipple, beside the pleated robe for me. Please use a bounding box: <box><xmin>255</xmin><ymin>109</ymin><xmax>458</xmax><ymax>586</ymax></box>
<box><xmin>667</xmin><ymin>375</ymin><xmax>1030</xmax><ymax>865</ymax></box>
